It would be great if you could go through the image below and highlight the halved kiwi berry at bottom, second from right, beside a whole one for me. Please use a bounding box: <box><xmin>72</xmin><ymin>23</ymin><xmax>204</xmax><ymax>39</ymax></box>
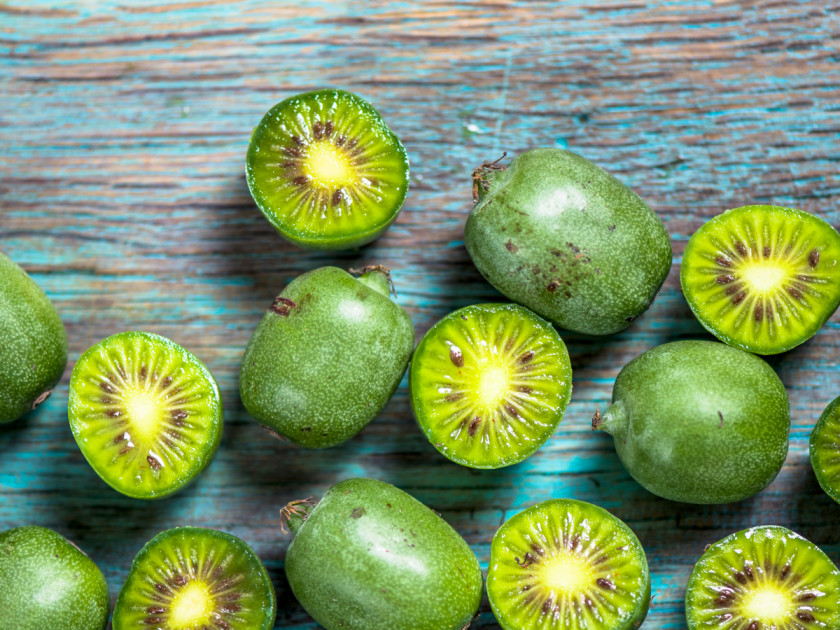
<box><xmin>487</xmin><ymin>499</ymin><xmax>650</xmax><ymax>630</ymax></box>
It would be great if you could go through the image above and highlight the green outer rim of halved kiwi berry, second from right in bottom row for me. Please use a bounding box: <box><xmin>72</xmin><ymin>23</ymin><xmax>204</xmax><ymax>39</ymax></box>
<box><xmin>487</xmin><ymin>499</ymin><xmax>651</xmax><ymax>630</ymax></box>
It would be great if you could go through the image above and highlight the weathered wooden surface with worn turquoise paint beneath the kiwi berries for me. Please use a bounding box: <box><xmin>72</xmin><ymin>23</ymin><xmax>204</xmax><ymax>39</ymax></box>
<box><xmin>0</xmin><ymin>0</ymin><xmax>840</xmax><ymax>630</ymax></box>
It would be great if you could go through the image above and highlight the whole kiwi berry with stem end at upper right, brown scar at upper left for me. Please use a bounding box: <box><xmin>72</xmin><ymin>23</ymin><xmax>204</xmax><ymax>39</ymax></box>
<box><xmin>239</xmin><ymin>267</ymin><xmax>414</xmax><ymax>448</ymax></box>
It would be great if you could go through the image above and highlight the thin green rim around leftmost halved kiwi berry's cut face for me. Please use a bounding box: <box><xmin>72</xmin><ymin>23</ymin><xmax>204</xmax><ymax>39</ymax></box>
<box><xmin>68</xmin><ymin>330</ymin><xmax>224</xmax><ymax>500</ymax></box>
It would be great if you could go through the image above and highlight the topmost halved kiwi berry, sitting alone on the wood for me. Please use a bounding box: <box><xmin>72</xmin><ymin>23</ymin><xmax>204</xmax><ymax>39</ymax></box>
<box><xmin>246</xmin><ymin>90</ymin><xmax>408</xmax><ymax>250</ymax></box>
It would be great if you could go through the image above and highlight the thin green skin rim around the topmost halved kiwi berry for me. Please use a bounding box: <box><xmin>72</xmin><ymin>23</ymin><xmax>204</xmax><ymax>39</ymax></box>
<box><xmin>246</xmin><ymin>89</ymin><xmax>409</xmax><ymax>251</ymax></box>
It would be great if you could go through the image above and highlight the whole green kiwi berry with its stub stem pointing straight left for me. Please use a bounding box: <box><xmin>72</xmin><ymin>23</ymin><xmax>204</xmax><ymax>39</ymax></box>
<box><xmin>599</xmin><ymin>341</ymin><xmax>790</xmax><ymax>503</ymax></box>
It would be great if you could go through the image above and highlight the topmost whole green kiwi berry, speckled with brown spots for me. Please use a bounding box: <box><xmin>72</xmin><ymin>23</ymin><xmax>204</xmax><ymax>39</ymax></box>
<box><xmin>464</xmin><ymin>148</ymin><xmax>671</xmax><ymax>335</ymax></box>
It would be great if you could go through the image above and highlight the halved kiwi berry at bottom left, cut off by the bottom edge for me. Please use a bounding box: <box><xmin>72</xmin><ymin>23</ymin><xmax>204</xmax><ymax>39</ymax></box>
<box><xmin>113</xmin><ymin>527</ymin><xmax>277</xmax><ymax>630</ymax></box>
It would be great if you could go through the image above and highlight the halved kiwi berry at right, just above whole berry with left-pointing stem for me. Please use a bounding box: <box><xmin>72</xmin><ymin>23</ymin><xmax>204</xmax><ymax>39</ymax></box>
<box><xmin>680</xmin><ymin>206</ymin><xmax>840</xmax><ymax>354</ymax></box>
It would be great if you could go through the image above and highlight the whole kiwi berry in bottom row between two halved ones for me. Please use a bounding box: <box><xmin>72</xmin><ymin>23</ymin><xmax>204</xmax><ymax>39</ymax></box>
<box><xmin>285</xmin><ymin>479</ymin><xmax>482</xmax><ymax>630</ymax></box>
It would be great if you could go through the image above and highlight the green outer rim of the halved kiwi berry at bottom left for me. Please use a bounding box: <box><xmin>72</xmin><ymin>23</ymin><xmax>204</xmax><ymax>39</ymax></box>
<box><xmin>112</xmin><ymin>527</ymin><xmax>277</xmax><ymax>630</ymax></box>
